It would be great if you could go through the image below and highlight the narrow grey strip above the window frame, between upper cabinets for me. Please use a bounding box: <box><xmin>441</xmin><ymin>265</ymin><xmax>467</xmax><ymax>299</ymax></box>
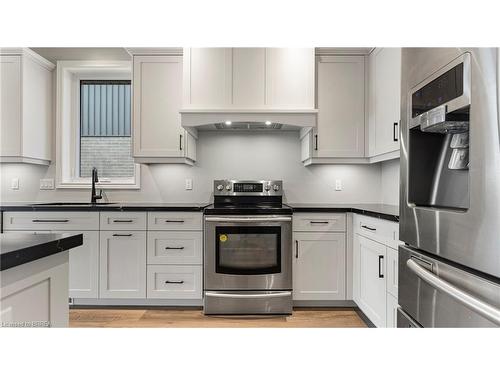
<box><xmin>31</xmin><ymin>47</ymin><xmax>130</xmax><ymax>63</ymax></box>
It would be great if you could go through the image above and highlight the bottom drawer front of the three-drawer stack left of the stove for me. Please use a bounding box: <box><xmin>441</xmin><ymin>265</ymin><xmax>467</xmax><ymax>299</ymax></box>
<box><xmin>147</xmin><ymin>265</ymin><xmax>202</xmax><ymax>299</ymax></box>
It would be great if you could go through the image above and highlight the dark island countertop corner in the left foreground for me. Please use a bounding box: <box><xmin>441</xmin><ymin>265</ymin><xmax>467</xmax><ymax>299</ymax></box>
<box><xmin>0</xmin><ymin>233</ymin><xmax>83</xmax><ymax>271</ymax></box>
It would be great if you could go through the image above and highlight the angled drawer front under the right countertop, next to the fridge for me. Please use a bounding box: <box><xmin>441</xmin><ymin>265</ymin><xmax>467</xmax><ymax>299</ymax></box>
<box><xmin>354</xmin><ymin>214</ymin><xmax>399</xmax><ymax>248</ymax></box>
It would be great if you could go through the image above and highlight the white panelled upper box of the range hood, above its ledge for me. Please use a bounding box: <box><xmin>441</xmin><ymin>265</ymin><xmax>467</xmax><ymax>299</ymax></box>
<box><xmin>183</xmin><ymin>48</ymin><xmax>314</xmax><ymax>110</ymax></box>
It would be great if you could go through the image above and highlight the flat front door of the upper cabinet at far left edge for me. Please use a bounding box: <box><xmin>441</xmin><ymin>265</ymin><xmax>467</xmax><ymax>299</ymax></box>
<box><xmin>0</xmin><ymin>56</ymin><xmax>22</xmax><ymax>156</ymax></box>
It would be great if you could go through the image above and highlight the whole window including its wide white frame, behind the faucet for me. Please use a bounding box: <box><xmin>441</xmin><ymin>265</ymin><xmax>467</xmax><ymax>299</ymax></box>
<box><xmin>56</xmin><ymin>61</ymin><xmax>140</xmax><ymax>189</ymax></box>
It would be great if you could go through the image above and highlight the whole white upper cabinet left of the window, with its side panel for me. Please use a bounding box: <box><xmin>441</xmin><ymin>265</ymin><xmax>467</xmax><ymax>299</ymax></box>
<box><xmin>0</xmin><ymin>48</ymin><xmax>54</xmax><ymax>164</ymax></box>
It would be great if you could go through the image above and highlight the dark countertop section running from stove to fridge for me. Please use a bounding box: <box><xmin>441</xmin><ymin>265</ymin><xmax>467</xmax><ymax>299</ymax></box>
<box><xmin>287</xmin><ymin>203</ymin><xmax>399</xmax><ymax>222</ymax></box>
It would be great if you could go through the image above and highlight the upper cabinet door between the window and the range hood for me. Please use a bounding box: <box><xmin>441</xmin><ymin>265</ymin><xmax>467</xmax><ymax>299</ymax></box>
<box><xmin>133</xmin><ymin>56</ymin><xmax>184</xmax><ymax>157</ymax></box>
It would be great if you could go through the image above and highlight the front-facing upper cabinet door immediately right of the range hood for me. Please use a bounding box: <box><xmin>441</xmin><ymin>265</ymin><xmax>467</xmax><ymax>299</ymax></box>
<box><xmin>315</xmin><ymin>56</ymin><xmax>365</xmax><ymax>157</ymax></box>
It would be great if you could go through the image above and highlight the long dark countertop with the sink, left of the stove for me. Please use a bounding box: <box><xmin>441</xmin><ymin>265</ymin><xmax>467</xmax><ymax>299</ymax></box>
<box><xmin>0</xmin><ymin>202</ymin><xmax>209</xmax><ymax>211</ymax></box>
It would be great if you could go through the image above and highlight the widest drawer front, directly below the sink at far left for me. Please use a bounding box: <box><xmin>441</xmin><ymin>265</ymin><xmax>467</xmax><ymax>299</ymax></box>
<box><xmin>3</xmin><ymin>211</ymin><xmax>99</xmax><ymax>231</ymax></box>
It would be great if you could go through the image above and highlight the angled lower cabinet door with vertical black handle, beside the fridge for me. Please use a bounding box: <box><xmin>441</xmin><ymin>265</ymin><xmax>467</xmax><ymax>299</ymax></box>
<box><xmin>358</xmin><ymin>235</ymin><xmax>386</xmax><ymax>327</ymax></box>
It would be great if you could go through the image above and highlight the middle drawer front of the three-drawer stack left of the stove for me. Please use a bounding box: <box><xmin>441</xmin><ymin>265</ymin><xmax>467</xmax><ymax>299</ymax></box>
<box><xmin>147</xmin><ymin>231</ymin><xmax>203</xmax><ymax>264</ymax></box>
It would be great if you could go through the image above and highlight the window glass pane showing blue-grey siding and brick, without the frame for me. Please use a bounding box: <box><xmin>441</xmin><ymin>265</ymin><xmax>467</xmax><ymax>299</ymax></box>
<box><xmin>79</xmin><ymin>80</ymin><xmax>134</xmax><ymax>178</ymax></box>
